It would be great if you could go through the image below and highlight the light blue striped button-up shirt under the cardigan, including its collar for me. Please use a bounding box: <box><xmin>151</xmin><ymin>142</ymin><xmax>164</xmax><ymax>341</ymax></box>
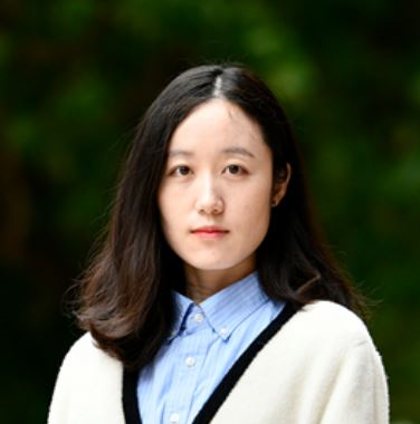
<box><xmin>137</xmin><ymin>272</ymin><xmax>284</xmax><ymax>424</ymax></box>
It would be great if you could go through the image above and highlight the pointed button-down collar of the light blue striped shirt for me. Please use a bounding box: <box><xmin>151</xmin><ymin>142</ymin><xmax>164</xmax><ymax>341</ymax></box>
<box><xmin>169</xmin><ymin>271</ymin><xmax>269</xmax><ymax>340</ymax></box>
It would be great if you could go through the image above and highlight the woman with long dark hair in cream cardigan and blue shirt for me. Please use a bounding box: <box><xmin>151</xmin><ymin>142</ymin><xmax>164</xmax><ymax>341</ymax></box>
<box><xmin>49</xmin><ymin>66</ymin><xmax>388</xmax><ymax>424</ymax></box>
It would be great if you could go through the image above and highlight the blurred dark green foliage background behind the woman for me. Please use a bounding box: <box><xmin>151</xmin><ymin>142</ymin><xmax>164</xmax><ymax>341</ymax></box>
<box><xmin>0</xmin><ymin>0</ymin><xmax>420</xmax><ymax>424</ymax></box>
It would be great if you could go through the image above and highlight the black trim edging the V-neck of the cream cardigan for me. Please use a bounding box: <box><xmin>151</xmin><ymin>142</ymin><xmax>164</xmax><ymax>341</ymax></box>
<box><xmin>123</xmin><ymin>303</ymin><xmax>298</xmax><ymax>424</ymax></box>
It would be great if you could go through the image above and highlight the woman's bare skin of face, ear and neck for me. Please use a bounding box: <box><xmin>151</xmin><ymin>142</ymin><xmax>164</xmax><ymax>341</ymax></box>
<box><xmin>158</xmin><ymin>99</ymin><xmax>290</xmax><ymax>302</ymax></box>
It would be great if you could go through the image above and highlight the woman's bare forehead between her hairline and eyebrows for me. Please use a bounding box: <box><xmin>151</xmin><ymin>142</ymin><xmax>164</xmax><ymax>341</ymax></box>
<box><xmin>169</xmin><ymin>99</ymin><xmax>268</xmax><ymax>151</ymax></box>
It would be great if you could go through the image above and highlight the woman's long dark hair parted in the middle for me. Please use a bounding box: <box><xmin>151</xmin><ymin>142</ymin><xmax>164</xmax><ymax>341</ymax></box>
<box><xmin>76</xmin><ymin>65</ymin><xmax>360</xmax><ymax>368</ymax></box>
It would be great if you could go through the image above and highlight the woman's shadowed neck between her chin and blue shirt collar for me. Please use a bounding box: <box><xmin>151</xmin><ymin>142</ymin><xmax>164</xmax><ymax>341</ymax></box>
<box><xmin>185</xmin><ymin>264</ymin><xmax>255</xmax><ymax>304</ymax></box>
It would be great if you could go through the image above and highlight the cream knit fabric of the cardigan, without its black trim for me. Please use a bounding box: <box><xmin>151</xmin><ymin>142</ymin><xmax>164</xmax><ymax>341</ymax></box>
<box><xmin>48</xmin><ymin>301</ymin><xmax>389</xmax><ymax>424</ymax></box>
